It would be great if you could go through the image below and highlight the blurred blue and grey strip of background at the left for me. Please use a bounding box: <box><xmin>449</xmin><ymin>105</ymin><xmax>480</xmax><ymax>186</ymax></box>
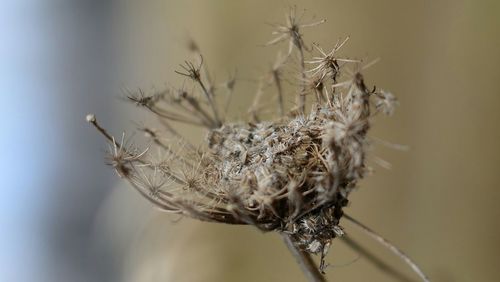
<box><xmin>0</xmin><ymin>0</ymin><xmax>117</xmax><ymax>281</ymax></box>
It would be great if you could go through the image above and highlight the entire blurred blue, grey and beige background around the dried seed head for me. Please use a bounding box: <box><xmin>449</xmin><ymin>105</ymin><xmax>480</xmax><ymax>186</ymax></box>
<box><xmin>0</xmin><ymin>0</ymin><xmax>500</xmax><ymax>282</ymax></box>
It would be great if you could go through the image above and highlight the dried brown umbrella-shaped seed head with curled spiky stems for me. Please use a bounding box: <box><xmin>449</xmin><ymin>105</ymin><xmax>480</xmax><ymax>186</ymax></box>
<box><xmin>87</xmin><ymin>8</ymin><xmax>429</xmax><ymax>281</ymax></box>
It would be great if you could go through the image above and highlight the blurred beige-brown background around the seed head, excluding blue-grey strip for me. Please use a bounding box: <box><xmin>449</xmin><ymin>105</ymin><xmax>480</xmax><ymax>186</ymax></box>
<box><xmin>91</xmin><ymin>0</ymin><xmax>500</xmax><ymax>281</ymax></box>
